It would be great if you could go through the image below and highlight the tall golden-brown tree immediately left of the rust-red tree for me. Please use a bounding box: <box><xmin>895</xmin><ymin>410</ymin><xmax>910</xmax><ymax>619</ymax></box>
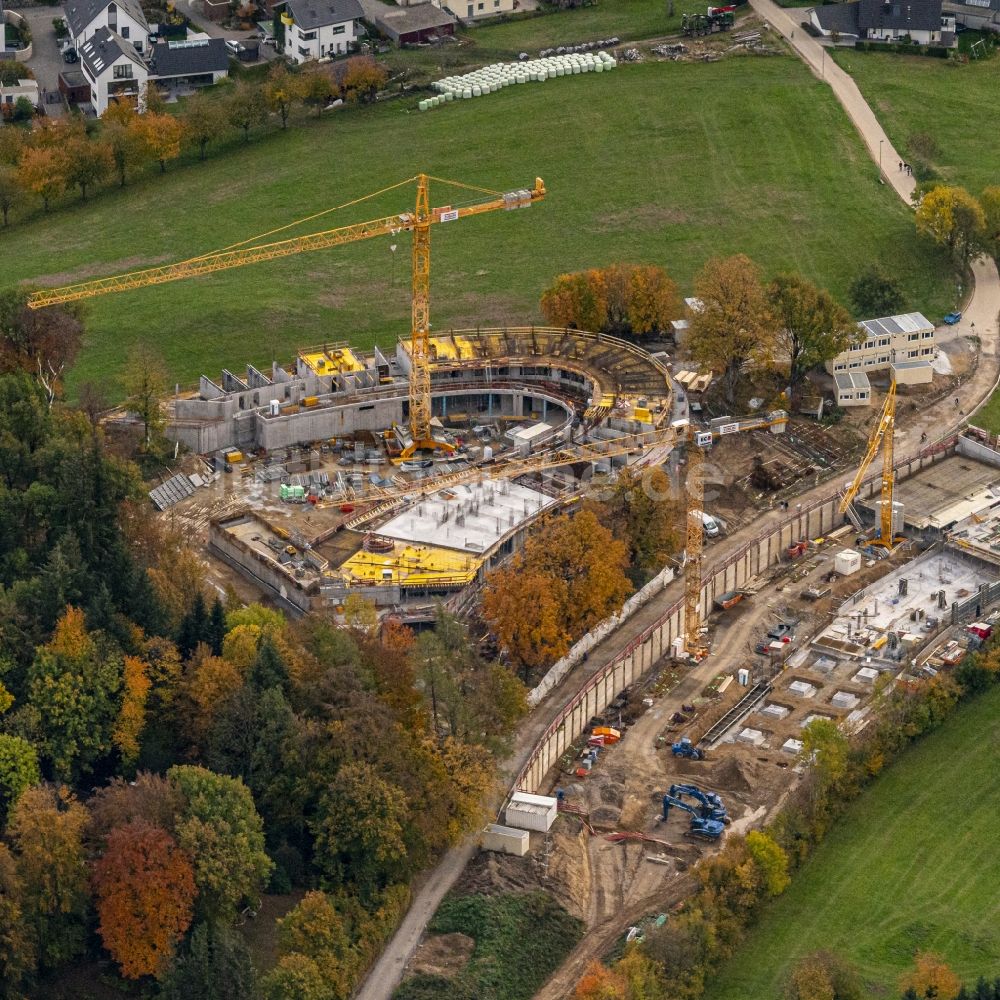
<box><xmin>7</xmin><ymin>785</ymin><xmax>87</xmax><ymax>969</ymax></box>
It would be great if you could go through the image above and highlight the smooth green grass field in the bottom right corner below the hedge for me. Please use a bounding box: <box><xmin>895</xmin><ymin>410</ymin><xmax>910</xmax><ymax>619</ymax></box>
<box><xmin>706</xmin><ymin>689</ymin><xmax>1000</xmax><ymax>1000</ymax></box>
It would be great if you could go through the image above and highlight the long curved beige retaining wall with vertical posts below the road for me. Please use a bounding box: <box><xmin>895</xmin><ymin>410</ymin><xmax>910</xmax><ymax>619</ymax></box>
<box><xmin>513</xmin><ymin>439</ymin><xmax>955</xmax><ymax>792</ymax></box>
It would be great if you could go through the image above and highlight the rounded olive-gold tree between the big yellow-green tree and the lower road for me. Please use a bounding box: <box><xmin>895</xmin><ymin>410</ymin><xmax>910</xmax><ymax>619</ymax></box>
<box><xmin>312</xmin><ymin>762</ymin><xmax>409</xmax><ymax>894</ymax></box>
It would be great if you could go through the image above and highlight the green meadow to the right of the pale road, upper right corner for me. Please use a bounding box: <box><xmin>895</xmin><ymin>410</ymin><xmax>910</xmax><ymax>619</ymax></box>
<box><xmin>835</xmin><ymin>50</ymin><xmax>1000</xmax><ymax>194</ymax></box>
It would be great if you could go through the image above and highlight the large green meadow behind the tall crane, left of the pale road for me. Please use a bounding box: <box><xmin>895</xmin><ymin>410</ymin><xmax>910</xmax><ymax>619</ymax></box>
<box><xmin>2</xmin><ymin>57</ymin><xmax>951</xmax><ymax>396</ymax></box>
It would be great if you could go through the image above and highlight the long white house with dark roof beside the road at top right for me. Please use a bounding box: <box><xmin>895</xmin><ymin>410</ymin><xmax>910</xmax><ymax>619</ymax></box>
<box><xmin>809</xmin><ymin>0</ymin><xmax>957</xmax><ymax>48</ymax></box>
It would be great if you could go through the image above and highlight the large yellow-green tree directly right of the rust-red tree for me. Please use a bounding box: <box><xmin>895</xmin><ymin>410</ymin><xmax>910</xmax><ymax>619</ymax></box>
<box><xmin>167</xmin><ymin>765</ymin><xmax>273</xmax><ymax>917</ymax></box>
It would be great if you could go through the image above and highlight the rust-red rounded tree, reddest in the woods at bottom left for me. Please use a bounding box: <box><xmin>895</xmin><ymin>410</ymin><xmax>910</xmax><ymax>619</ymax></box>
<box><xmin>93</xmin><ymin>820</ymin><xmax>195</xmax><ymax>979</ymax></box>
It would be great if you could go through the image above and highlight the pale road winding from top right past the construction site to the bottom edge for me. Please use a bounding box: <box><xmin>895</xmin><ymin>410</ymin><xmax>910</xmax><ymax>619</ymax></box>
<box><xmin>356</xmin><ymin>17</ymin><xmax>1000</xmax><ymax>1000</ymax></box>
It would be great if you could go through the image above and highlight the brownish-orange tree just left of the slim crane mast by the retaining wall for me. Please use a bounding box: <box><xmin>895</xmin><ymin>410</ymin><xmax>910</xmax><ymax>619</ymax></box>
<box><xmin>597</xmin><ymin>468</ymin><xmax>681</xmax><ymax>583</ymax></box>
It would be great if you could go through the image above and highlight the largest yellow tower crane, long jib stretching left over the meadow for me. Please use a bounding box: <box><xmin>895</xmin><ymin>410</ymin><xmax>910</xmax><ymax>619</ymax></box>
<box><xmin>28</xmin><ymin>174</ymin><xmax>545</xmax><ymax>458</ymax></box>
